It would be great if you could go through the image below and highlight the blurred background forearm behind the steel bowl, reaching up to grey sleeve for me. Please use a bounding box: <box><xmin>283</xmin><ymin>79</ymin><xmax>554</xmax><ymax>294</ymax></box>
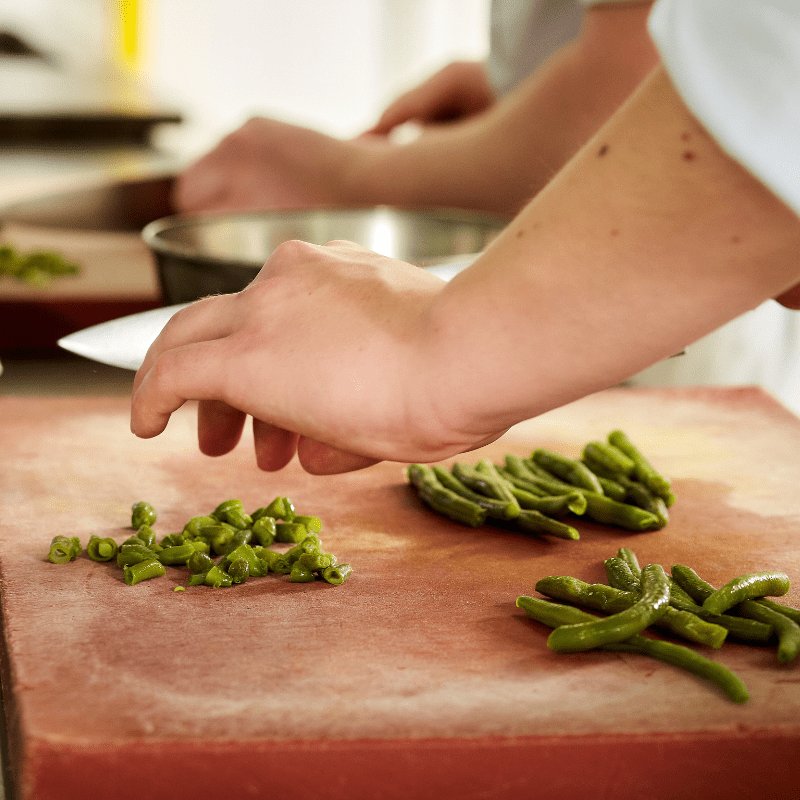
<box><xmin>349</xmin><ymin>3</ymin><xmax>656</xmax><ymax>214</ymax></box>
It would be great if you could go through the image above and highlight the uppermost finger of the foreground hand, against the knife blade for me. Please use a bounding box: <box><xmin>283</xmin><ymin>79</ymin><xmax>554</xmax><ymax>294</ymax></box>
<box><xmin>133</xmin><ymin>295</ymin><xmax>238</xmax><ymax>392</ymax></box>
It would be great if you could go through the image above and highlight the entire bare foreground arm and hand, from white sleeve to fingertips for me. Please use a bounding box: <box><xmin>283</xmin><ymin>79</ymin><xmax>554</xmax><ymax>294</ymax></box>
<box><xmin>132</xmin><ymin>70</ymin><xmax>800</xmax><ymax>472</ymax></box>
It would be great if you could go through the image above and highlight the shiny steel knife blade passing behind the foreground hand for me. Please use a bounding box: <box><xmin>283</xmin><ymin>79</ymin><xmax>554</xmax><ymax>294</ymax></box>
<box><xmin>58</xmin><ymin>254</ymin><xmax>477</xmax><ymax>370</ymax></box>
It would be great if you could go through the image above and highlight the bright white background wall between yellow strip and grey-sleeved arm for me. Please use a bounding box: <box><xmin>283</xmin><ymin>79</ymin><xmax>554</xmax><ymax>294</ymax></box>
<box><xmin>140</xmin><ymin>0</ymin><xmax>488</xmax><ymax>158</ymax></box>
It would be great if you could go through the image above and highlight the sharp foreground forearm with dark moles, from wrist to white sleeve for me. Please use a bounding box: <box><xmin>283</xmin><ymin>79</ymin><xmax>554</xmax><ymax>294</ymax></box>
<box><xmin>422</xmin><ymin>70</ymin><xmax>800</xmax><ymax>438</ymax></box>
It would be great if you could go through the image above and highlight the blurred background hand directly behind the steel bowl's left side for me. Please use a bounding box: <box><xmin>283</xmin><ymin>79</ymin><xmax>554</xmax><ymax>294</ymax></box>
<box><xmin>174</xmin><ymin>118</ymin><xmax>369</xmax><ymax>212</ymax></box>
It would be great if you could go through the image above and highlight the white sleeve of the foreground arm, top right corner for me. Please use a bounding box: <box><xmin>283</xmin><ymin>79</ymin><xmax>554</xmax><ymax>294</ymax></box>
<box><xmin>649</xmin><ymin>0</ymin><xmax>800</xmax><ymax>214</ymax></box>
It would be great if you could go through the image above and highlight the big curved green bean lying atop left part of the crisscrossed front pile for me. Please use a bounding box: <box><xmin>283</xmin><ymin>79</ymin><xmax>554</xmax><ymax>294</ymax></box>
<box><xmin>547</xmin><ymin>564</ymin><xmax>669</xmax><ymax>652</ymax></box>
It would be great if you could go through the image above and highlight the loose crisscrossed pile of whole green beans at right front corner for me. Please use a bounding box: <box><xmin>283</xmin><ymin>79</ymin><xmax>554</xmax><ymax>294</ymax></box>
<box><xmin>516</xmin><ymin>547</ymin><xmax>800</xmax><ymax>703</ymax></box>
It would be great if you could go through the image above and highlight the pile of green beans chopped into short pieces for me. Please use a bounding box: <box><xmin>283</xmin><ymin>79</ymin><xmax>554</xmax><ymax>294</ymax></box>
<box><xmin>48</xmin><ymin>497</ymin><xmax>352</xmax><ymax>590</ymax></box>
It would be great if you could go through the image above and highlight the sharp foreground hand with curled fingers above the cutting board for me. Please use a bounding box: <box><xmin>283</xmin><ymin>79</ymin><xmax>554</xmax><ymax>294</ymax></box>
<box><xmin>131</xmin><ymin>242</ymin><xmax>501</xmax><ymax>473</ymax></box>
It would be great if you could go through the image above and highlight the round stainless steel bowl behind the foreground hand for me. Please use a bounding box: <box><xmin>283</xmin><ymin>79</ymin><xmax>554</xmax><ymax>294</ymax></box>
<box><xmin>142</xmin><ymin>206</ymin><xmax>507</xmax><ymax>304</ymax></box>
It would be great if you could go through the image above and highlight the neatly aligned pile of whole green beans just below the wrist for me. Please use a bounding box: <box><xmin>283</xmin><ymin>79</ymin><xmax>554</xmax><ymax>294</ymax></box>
<box><xmin>406</xmin><ymin>430</ymin><xmax>675</xmax><ymax>541</ymax></box>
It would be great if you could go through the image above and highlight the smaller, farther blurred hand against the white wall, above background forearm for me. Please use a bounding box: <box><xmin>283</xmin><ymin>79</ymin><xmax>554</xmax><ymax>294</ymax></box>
<box><xmin>367</xmin><ymin>61</ymin><xmax>495</xmax><ymax>135</ymax></box>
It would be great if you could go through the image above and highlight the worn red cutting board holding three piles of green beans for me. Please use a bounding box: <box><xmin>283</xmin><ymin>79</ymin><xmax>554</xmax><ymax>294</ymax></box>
<box><xmin>0</xmin><ymin>389</ymin><xmax>800</xmax><ymax>800</ymax></box>
